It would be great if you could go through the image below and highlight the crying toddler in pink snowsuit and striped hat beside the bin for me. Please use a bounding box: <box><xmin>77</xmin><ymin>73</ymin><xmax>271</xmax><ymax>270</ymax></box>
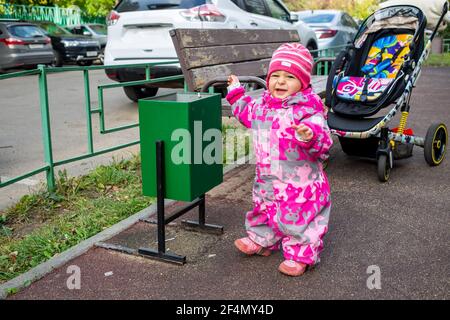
<box><xmin>227</xmin><ymin>43</ymin><xmax>332</xmax><ymax>276</ymax></box>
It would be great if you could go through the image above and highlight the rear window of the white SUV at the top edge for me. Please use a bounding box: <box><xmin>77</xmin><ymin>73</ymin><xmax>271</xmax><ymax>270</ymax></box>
<box><xmin>116</xmin><ymin>0</ymin><xmax>209</xmax><ymax>12</ymax></box>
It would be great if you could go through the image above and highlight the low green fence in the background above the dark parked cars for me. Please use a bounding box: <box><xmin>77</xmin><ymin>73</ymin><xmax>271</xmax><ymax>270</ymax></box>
<box><xmin>0</xmin><ymin>3</ymin><xmax>105</xmax><ymax>26</ymax></box>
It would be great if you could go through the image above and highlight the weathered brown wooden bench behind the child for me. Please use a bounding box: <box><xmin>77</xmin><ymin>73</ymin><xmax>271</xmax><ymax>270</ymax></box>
<box><xmin>170</xmin><ymin>29</ymin><xmax>326</xmax><ymax>116</ymax></box>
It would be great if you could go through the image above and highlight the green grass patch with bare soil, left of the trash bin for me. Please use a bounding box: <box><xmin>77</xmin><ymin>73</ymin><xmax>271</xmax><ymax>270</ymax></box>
<box><xmin>0</xmin><ymin>156</ymin><xmax>154</xmax><ymax>282</ymax></box>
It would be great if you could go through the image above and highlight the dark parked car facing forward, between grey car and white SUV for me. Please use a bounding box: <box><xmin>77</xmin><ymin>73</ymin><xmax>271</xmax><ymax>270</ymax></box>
<box><xmin>34</xmin><ymin>21</ymin><xmax>101</xmax><ymax>67</ymax></box>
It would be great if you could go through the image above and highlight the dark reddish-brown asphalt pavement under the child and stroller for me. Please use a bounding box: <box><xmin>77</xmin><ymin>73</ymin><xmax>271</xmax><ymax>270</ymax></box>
<box><xmin>4</xmin><ymin>68</ymin><xmax>450</xmax><ymax>300</ymax></box>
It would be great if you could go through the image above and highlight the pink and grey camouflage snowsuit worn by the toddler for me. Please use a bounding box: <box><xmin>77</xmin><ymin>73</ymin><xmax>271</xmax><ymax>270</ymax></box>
<box><xmin>227</xmin><ymin>87</ymin><xmax>332</xmax><ymax>265</ymax></box>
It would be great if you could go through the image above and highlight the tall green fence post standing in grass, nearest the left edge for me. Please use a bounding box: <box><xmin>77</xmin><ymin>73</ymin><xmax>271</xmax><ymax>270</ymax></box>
<box><xmin>38</xmin><ymin>65</ymin><xmax>55</xmax><ymax>191</ymax></box>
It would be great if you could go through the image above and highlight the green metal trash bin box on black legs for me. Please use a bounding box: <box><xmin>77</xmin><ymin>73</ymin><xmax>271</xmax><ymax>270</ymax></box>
<box><xmin>138</xmin><ymin>93</ymin><xmax>223</xmax><ymax>201</ymax></box>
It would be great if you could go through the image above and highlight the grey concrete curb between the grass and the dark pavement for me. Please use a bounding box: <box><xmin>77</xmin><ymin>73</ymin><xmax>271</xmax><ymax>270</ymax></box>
<box><xmin>0</xmin><ymin>157</ymin><xmax>253</xmax><ymax>300</ymax></box>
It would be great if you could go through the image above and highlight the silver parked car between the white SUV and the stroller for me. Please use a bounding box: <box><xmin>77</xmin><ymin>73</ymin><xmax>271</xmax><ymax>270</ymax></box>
<box><xmin>296</xmin><ymin>10</ymin><xmax>358</xmax><ymax>49</ymax></box>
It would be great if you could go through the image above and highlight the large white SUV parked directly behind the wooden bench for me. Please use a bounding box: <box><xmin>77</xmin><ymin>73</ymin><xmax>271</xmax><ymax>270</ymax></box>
<box><xmin>104</xmin><ymin>0</ymin><xmax>318</xmax><ymax>101</ymax></box>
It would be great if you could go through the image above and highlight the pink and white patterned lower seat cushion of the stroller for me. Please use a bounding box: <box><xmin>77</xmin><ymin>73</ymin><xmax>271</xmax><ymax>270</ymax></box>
<box><xmin>336</xmin><ymin>77</ymin><xmax>393</xmax><ymax>101</ymax></box>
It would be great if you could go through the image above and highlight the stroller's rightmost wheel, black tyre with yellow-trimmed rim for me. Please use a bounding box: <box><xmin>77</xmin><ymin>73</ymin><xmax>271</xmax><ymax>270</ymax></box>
<box><xmin>424</xmin><ymin>123</ymin><xmax>448</xmax><ymax>167</ymax></box>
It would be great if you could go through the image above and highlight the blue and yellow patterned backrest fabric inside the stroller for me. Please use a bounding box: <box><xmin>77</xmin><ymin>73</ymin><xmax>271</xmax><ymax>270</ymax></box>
<box><xmin>361</xmin><ymin>34</ymin><xmax>413</xmax><ymax>79</ymax></box>
